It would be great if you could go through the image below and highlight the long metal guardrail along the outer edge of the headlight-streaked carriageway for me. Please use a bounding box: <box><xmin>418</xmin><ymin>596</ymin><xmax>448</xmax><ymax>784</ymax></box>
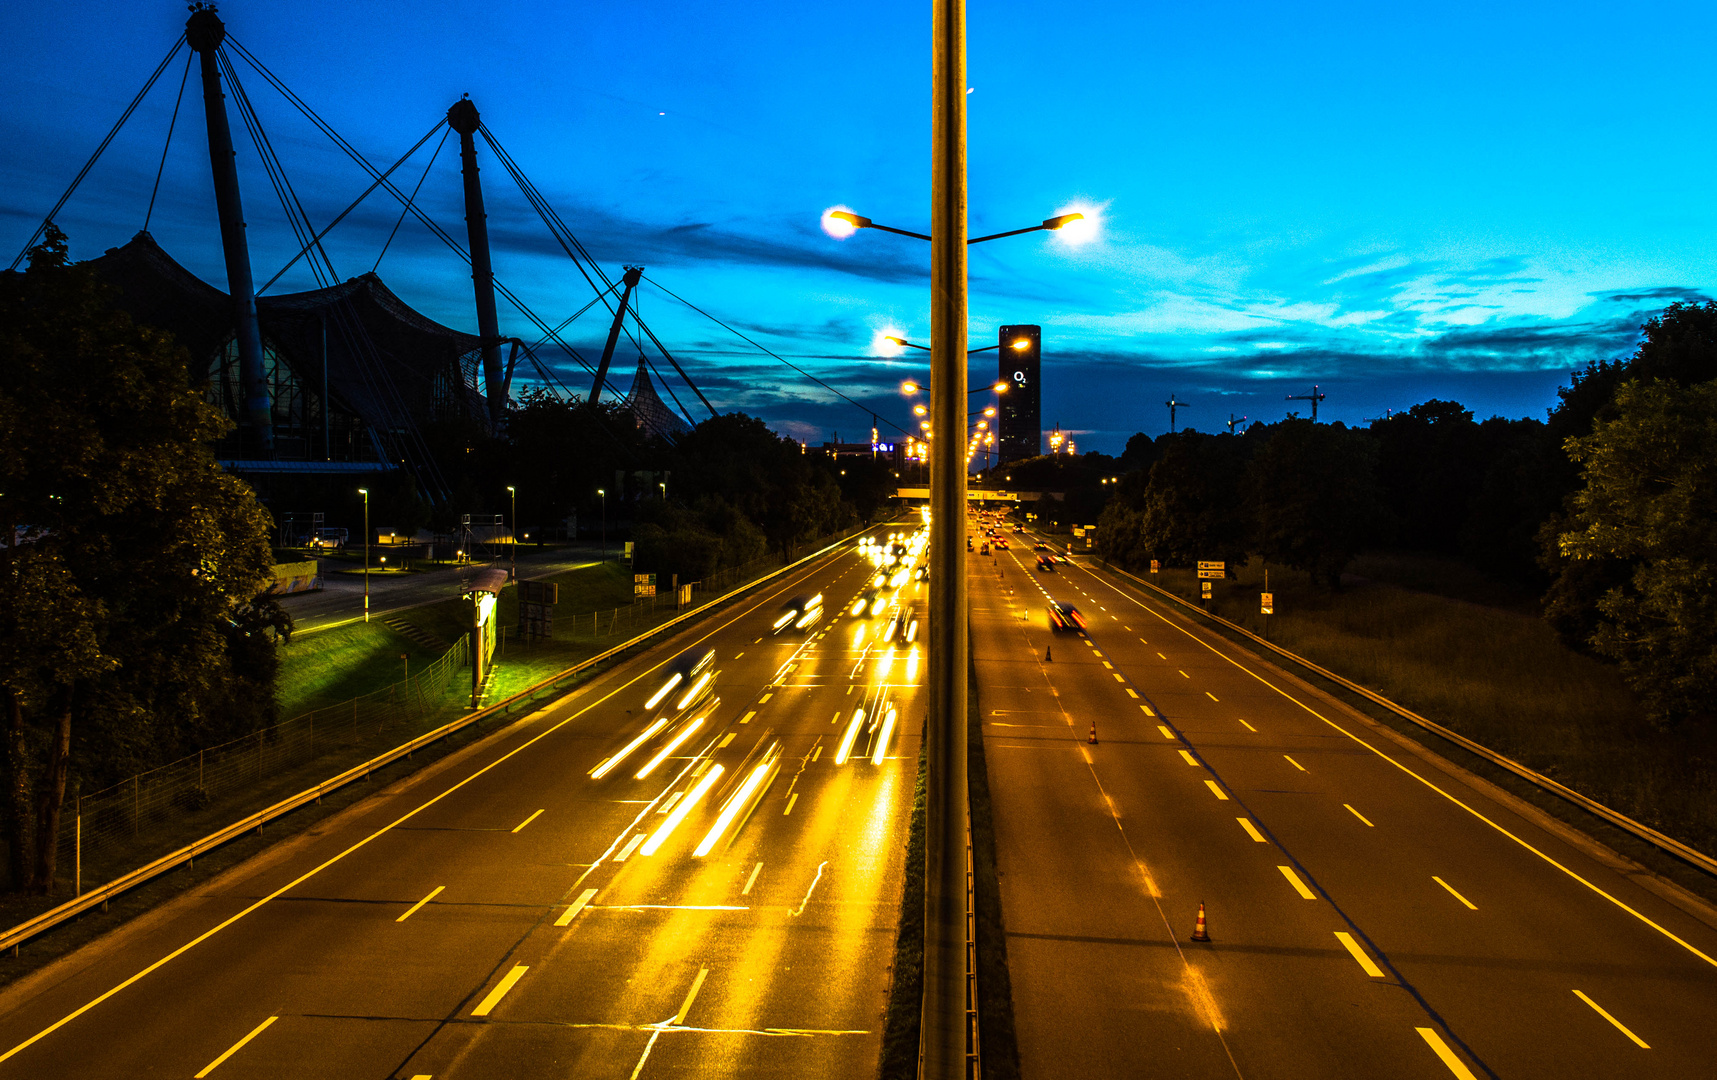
<box><xmin>0</xmin><ymin>529</ymin><xmax>865</xmax><ymax>950</ymax></box>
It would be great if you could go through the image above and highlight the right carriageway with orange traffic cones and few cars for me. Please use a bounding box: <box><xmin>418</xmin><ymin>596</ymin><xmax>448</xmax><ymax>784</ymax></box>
<box><xmin>968</xmin><ymin>518</ymin><xmax>1717</xmax><ymax>1080</ymax></box>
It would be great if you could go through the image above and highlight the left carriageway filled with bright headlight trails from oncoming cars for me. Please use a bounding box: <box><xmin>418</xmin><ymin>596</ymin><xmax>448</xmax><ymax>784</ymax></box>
<box><xmin>0</xmin><ymin>525</ymin><xmax>922</xmax><ymax>1080</ymax></box>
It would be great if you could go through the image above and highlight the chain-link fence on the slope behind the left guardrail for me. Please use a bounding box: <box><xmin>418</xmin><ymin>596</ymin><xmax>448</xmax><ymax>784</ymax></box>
<box><xmin>60</xmin><ymin>637</ymin><xmax>470</xmax><ymax>889</ymax></box>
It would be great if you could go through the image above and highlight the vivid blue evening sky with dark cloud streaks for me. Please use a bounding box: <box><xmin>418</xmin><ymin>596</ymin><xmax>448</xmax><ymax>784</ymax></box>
<box><xmin>0</xmin><ymin>0</ymin><xmax>1717</xmax><ymax>452</ymax></box>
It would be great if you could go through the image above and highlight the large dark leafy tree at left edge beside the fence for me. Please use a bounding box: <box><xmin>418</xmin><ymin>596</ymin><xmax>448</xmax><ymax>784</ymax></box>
<box><xmin>0</xmin><ymin>227</ymin><xmax>273</xmax><ymax>893</ymax></box>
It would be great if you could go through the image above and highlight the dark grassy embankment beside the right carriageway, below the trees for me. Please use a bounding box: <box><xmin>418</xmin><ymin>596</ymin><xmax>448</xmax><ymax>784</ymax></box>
<box><xmin>1142</xmin><ymin>553</ymin><xmax>1717</xmax><ymax>893</ymax></box>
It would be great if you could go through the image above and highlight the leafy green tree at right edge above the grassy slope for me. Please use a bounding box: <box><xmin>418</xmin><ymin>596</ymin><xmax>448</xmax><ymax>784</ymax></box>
<box><xmin>1557</xmin><ymin>379</ymin><xmax>1717</xmax><ymax>725</ymax></box>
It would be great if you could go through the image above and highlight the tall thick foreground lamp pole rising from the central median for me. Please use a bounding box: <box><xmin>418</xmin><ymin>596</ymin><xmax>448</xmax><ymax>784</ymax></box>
<box><xmin>919</xmin><ymin>0</ymin><xmax>970</xmax><ymax>1080</ymax></box>
